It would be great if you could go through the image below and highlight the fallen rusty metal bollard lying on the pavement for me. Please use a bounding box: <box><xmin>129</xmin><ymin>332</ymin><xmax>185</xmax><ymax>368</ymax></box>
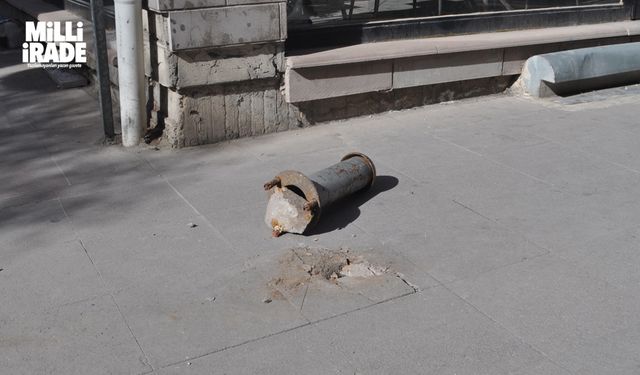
<box><xmin>264</xmin><ymin>152</ymin><xmax>376</xmax><ymax>237</ymax></box>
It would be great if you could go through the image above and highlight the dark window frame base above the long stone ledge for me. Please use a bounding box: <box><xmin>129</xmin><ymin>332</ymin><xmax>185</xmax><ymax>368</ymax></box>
<box><xmin>286</xmin><ymin>0</ymin><xmax>640</xmax><ymax>53</ymax></box>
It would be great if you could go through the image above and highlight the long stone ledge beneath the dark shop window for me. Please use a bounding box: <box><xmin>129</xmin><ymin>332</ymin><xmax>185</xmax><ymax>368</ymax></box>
<box><xmin>285</xmin><ymin>21</ymin><xmax>640</xmax><ymax>103</ymax></box>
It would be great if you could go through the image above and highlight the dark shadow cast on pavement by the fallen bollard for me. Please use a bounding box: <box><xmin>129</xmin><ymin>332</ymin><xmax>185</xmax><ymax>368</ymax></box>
<box><xmin>305</xmin><ymin>176</ymin><xmax>398</xmax><ymax>236</ymax></box>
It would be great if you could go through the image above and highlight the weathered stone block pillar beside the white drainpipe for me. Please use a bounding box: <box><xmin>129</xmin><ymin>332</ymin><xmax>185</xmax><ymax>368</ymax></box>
<box><xmin>143</xmin><ymin>0</ymin><xmax>292</xmax><ymax>147</ymax></box>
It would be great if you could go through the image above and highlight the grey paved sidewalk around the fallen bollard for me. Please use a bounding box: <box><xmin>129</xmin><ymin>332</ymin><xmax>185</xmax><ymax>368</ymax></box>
<box><xmin>0</xmin><ymin>48</ymin><xmax>640</xmax><ymax>375</ymax></box>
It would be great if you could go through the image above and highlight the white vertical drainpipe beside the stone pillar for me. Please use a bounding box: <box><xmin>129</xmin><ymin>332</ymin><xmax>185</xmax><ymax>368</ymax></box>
<box><xmin>114</xmin><ymin>0</ymin><xmax>146</xmax><ymax>147</ymax></box>
